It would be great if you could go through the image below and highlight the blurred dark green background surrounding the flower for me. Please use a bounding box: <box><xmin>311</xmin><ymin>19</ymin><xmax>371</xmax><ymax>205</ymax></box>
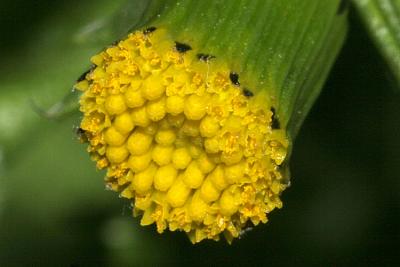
<box><xmin>0</xmin><ymin>0</ymin><xmax>400</xmax><ymax>266</ymax></box>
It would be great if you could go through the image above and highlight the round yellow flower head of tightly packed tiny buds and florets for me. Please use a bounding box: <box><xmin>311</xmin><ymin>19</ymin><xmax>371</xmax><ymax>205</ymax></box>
<box><xmin>76</xmin><ymin>29</ymin><xmax>288</xmax><ymax>243</ymax></box>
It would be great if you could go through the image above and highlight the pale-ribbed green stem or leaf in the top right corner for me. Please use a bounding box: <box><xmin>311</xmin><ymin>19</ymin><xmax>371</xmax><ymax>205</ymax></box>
<box><xmin>353</xmin><ymin>0</ymin><xmax>400</xmax><ymax>86</ymax></box>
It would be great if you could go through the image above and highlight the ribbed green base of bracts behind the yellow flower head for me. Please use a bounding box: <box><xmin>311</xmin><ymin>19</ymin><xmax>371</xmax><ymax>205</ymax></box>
<box><xmin>139</xmin><ymin>0</ymin><xmax>347</xmax><ymax>139</ymax></box>
